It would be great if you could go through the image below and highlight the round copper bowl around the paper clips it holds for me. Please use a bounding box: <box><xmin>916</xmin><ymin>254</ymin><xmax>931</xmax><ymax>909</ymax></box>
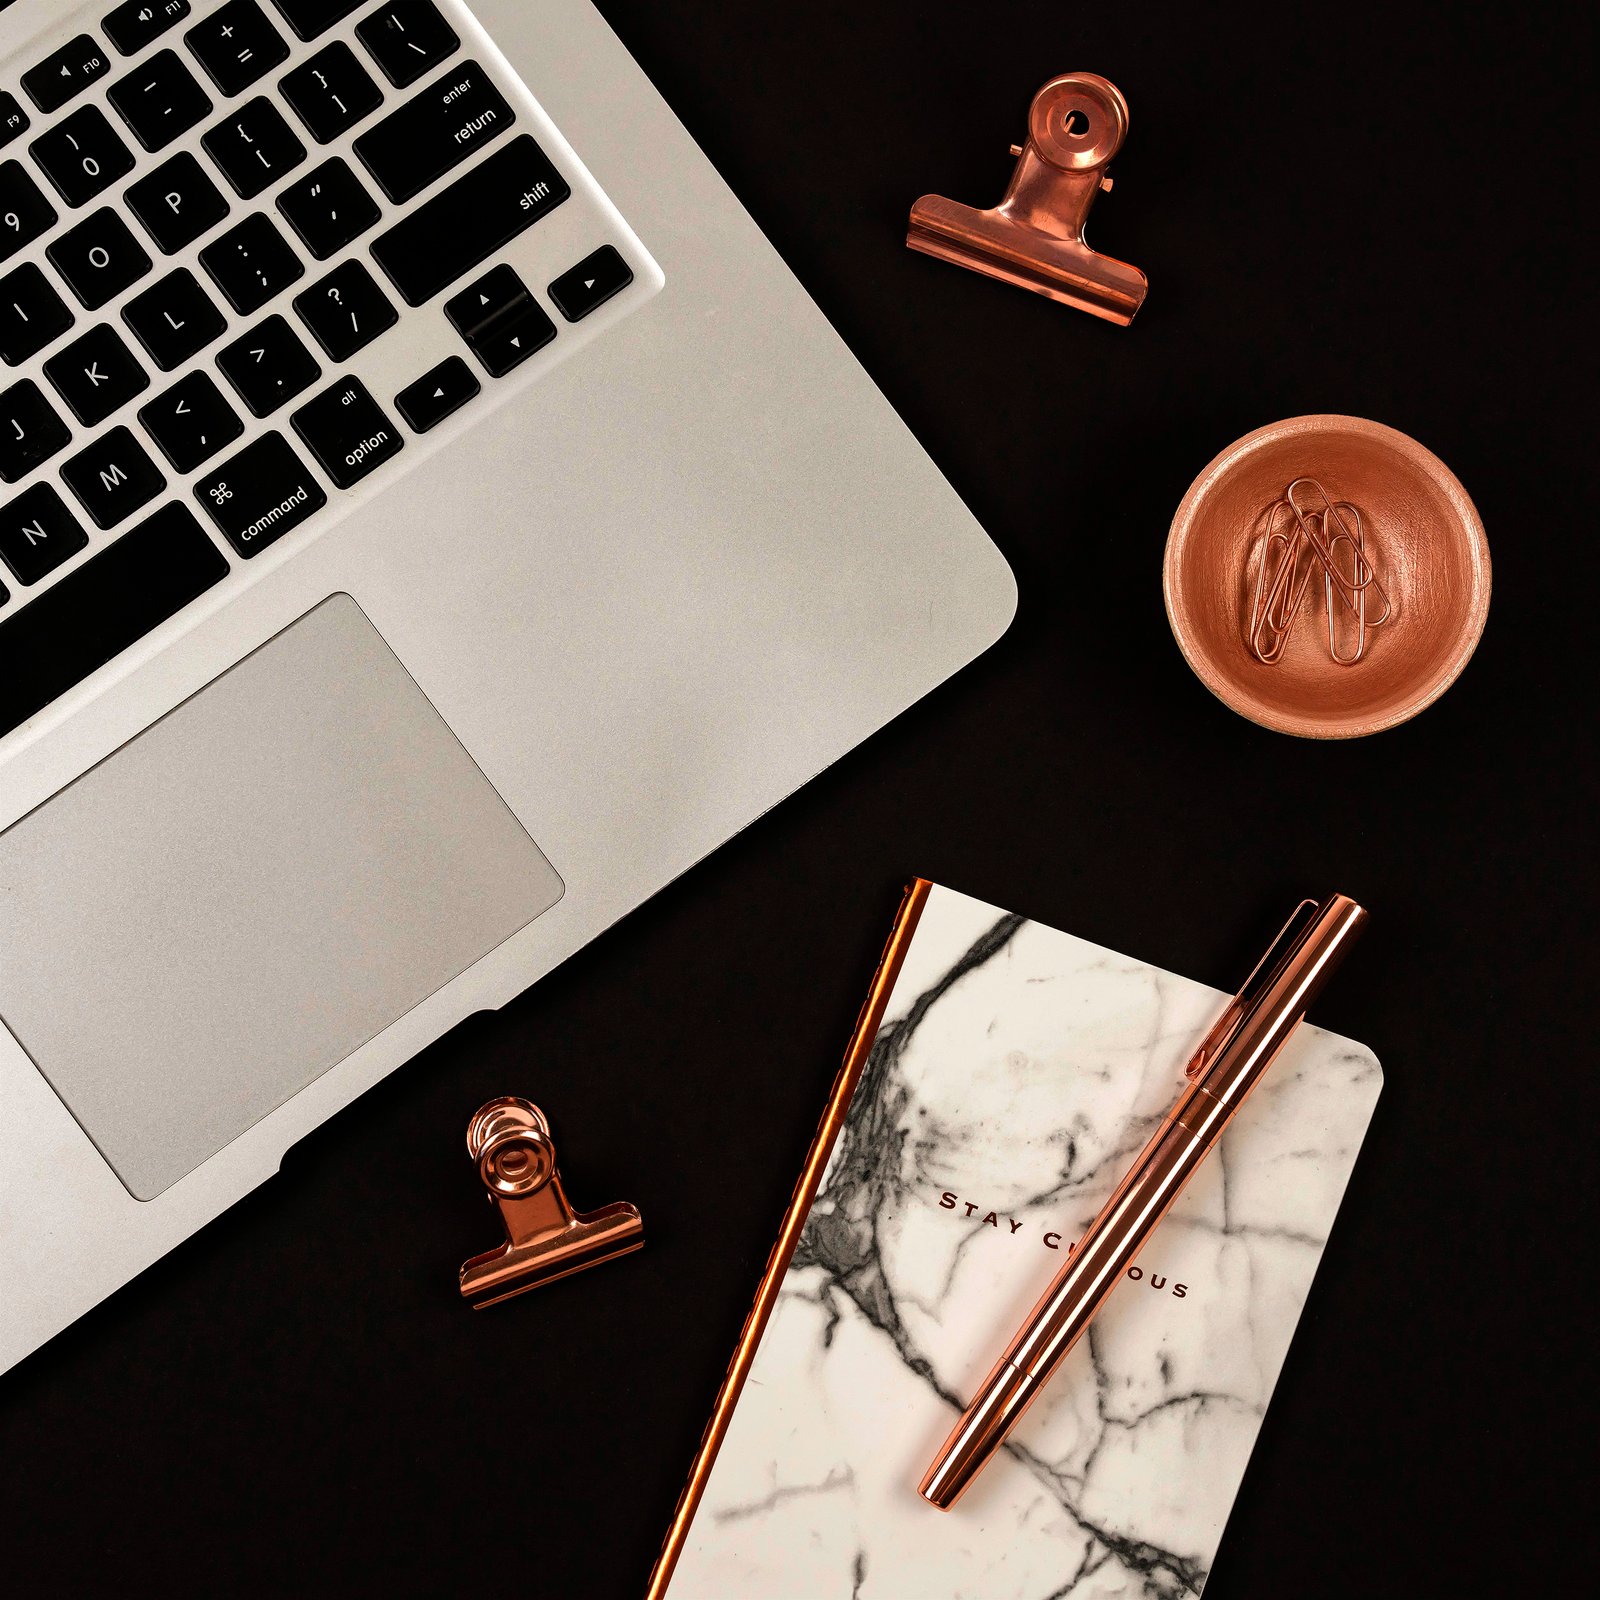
<box><xmin>1163</xmin><ymin>416</ymin><xmax>1490</xmax><ymax>739</ymax></box>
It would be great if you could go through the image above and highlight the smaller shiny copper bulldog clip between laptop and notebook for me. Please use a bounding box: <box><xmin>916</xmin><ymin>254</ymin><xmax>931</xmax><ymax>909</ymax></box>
<box><xmin>461</xmin><ymin>1094</ymin><xmax>645</xmax><ymax>1310</ymax></box>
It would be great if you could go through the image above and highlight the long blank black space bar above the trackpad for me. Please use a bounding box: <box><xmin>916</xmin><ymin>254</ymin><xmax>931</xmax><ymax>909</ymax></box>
<box><xmin>0</xmin><ymin>506</ymin><xmax>227</xmax><ymax>733</ymax></box>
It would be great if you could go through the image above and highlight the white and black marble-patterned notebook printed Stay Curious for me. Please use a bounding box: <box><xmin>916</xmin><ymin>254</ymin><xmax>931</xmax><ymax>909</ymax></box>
<box><xmin>651</xmin><ymin>883</ymin><xmax>1382</xmax><ymax>1600</ymax></box>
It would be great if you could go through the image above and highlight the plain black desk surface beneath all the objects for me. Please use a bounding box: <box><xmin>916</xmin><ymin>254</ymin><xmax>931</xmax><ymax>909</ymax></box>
<box><xmin>0</xmin><ymin>0</ymin><xmax>1597</xmax><ymax>1600</ymax></box>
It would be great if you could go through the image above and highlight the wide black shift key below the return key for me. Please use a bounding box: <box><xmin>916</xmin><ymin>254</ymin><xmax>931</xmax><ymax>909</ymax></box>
<box><xmin>373</xmin><ymin>133</ymin><xmax>571</xmax><ymax>306</ymax></box>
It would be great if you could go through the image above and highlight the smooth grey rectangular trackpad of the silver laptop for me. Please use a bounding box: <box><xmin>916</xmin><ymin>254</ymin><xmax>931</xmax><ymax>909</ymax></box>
<box><xmin>0</xmin><ymin>595</ymin><xmax>562</xmax><ymax>1200</ymax></box>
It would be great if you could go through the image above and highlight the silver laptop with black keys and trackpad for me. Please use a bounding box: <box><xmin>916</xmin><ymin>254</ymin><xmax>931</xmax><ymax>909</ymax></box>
<box><xmin>0</xmin><ymin>0</ymin><xmax>1014</xmax><ymax>1368</ymax></box>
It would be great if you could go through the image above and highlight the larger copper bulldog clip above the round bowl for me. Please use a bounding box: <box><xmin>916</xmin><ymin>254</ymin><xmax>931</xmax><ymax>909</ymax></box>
<box><xmin>906</xmin><ymin>72</ymin><xmax>1149</xmax><ymax>326</ymax></box>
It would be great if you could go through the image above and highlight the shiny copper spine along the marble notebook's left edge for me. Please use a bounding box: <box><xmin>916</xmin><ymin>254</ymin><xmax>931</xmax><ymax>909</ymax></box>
<box><xmin>645</xmin><ymin>878</ymin><xmax>933</xmax><ymax>1600</ymax></box>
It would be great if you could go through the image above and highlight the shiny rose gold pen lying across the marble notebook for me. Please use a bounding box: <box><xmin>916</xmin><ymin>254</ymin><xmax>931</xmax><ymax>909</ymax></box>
<box><xmin>920</xmin><ymin>894</ymin><xmax>1366</xmax><ymax>1510</ymax></box>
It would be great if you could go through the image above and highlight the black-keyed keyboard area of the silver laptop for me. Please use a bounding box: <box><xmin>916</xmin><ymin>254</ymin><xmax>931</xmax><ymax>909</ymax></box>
<box><xmin>0</xmin><ymin>0</ymin><xmax>659</xmax><ymax>734</ymax></box>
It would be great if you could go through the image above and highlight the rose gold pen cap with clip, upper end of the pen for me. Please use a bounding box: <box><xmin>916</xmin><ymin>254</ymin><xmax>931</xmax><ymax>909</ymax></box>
<box><xmin>1195</xmin><ymin>894</ymin><xmax>1366</xmax><ymax>1106</ymax></box>
